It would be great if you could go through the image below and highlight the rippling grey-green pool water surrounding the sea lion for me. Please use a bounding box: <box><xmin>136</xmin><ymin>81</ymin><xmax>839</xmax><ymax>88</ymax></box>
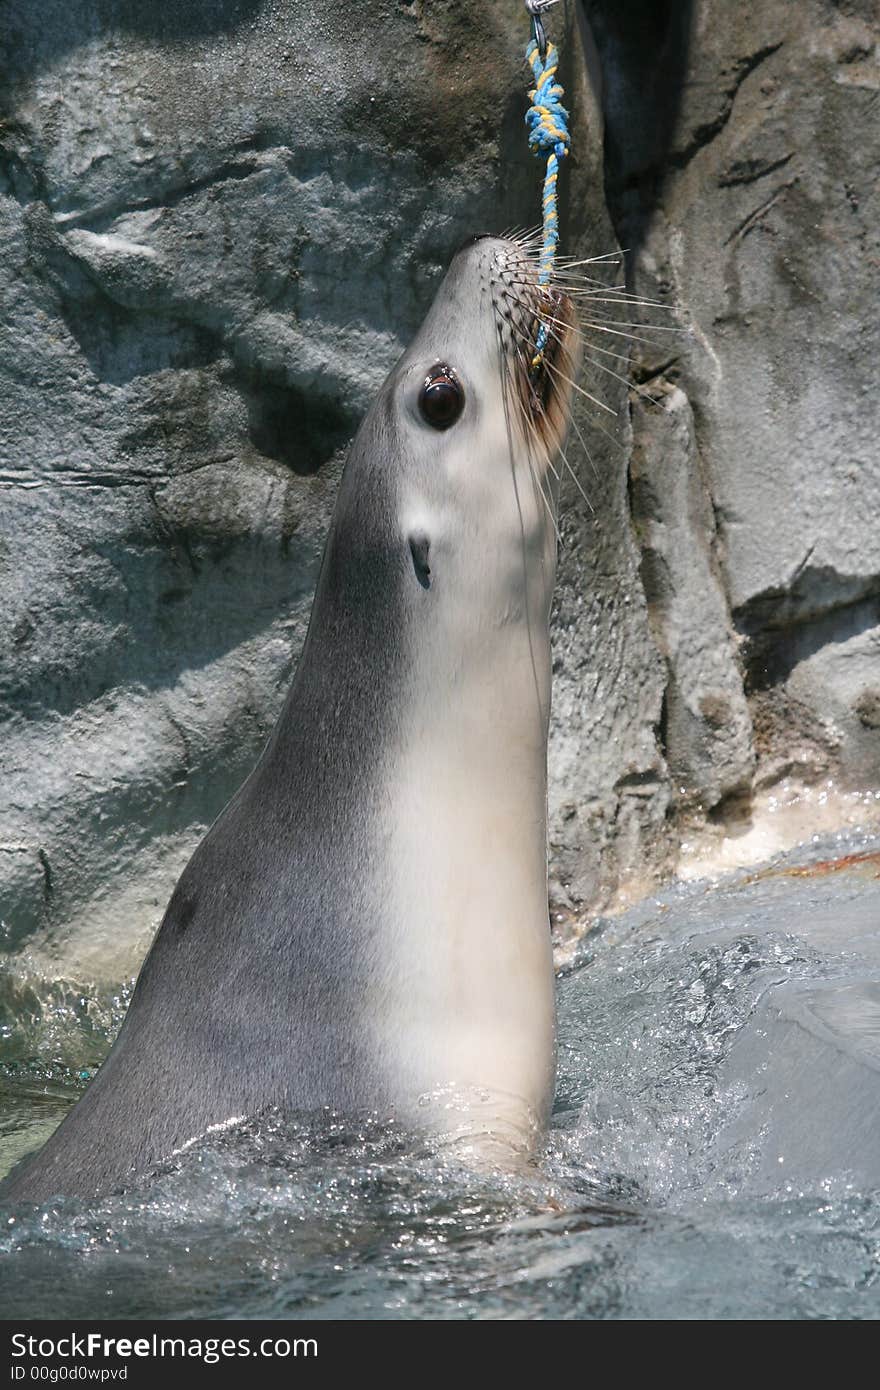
<box><xmin>0</xmin><ymin>838</ymin><xmax>880</xmax><ymax>1319</ymax></box>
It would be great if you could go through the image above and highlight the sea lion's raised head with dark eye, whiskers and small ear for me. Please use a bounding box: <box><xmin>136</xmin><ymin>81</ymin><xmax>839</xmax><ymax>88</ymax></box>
<box><xmin>329</xmin><ymin>236</ymin><xmax>578</xmax><ymax>639</ymax></box>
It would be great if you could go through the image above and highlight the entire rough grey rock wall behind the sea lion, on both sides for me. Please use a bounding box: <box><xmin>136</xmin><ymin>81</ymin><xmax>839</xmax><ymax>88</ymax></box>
<box><xmin>0</xmin><ymin>0</ymin><xmax>880</xmax><ymax>974</ymax></box>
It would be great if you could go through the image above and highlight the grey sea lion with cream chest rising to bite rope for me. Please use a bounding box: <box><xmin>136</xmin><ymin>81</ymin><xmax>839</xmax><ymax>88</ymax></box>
<box><xmin>6</xmin><ymin>236</ymin><xmax>577</xmax><ymax>1201</ymax></box>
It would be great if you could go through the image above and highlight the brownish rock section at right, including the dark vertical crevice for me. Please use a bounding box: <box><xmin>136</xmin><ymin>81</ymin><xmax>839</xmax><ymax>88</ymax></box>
<box><xmin>569</xmin><ymin>0</ymin><xmax>880</xmax><ymax>889</ymax></box>
